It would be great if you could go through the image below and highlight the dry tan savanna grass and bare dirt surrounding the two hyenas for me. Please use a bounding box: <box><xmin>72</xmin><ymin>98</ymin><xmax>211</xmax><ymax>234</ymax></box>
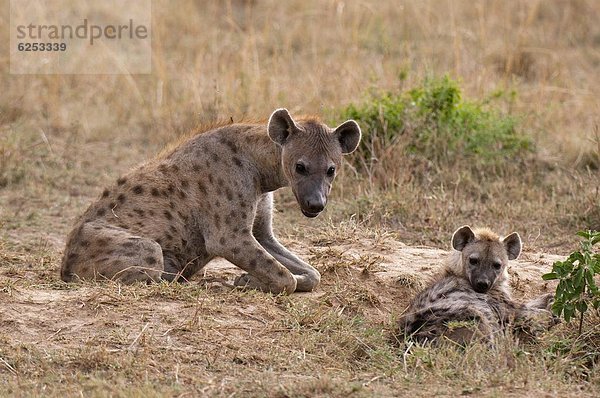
<box><xmin>0</xmin><ymin>0</ymin><xmax>600</xmax><ymax>397</ymax></box>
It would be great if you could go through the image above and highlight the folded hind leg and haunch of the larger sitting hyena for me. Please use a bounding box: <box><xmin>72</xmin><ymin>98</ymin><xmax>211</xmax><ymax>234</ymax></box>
<box><xmin>61</xmin><ymin>222</ymin><xmax>164</xmax><ymax>284</ymax></box>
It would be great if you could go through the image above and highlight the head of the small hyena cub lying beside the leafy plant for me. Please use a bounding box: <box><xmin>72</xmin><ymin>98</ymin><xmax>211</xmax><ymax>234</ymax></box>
<box><xmin>452</xmin><ymin>225</ymin><xmax>521</xmax><ymax>293</ymax></box>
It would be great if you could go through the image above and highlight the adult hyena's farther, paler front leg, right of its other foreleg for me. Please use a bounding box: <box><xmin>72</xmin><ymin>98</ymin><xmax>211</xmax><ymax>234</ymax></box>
<box><xmin>252</xmin><ymin>193</ymin><xmax>321</xmax><ymax>292</ymax></box>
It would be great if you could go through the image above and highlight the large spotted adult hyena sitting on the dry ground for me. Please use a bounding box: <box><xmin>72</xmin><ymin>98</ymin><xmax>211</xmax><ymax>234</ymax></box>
<box><xmin>61</xmin><ymin>109</ymin><xmax>361</xmax><ymax>293</ymax></box>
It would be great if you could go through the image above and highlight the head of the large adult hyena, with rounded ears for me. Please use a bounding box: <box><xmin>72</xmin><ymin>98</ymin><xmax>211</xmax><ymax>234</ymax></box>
<box><xmin>268</xmin><ymin>109</ymin><xmax>360</xmax><ymax>217</ymax></box>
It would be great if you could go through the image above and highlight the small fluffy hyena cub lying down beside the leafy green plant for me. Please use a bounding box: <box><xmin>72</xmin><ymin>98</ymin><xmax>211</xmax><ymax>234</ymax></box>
<box><xmin>400</xmin><ymin>226</ymin><xmax>553</xmax><ymax>344</ymax></box>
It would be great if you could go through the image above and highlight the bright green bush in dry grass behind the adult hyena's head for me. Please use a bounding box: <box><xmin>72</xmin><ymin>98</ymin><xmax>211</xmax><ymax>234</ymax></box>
<box><xmin>340</xmin><ymin>76</ymin><xmax>534</xmax><ymax>172</ymax></box>
